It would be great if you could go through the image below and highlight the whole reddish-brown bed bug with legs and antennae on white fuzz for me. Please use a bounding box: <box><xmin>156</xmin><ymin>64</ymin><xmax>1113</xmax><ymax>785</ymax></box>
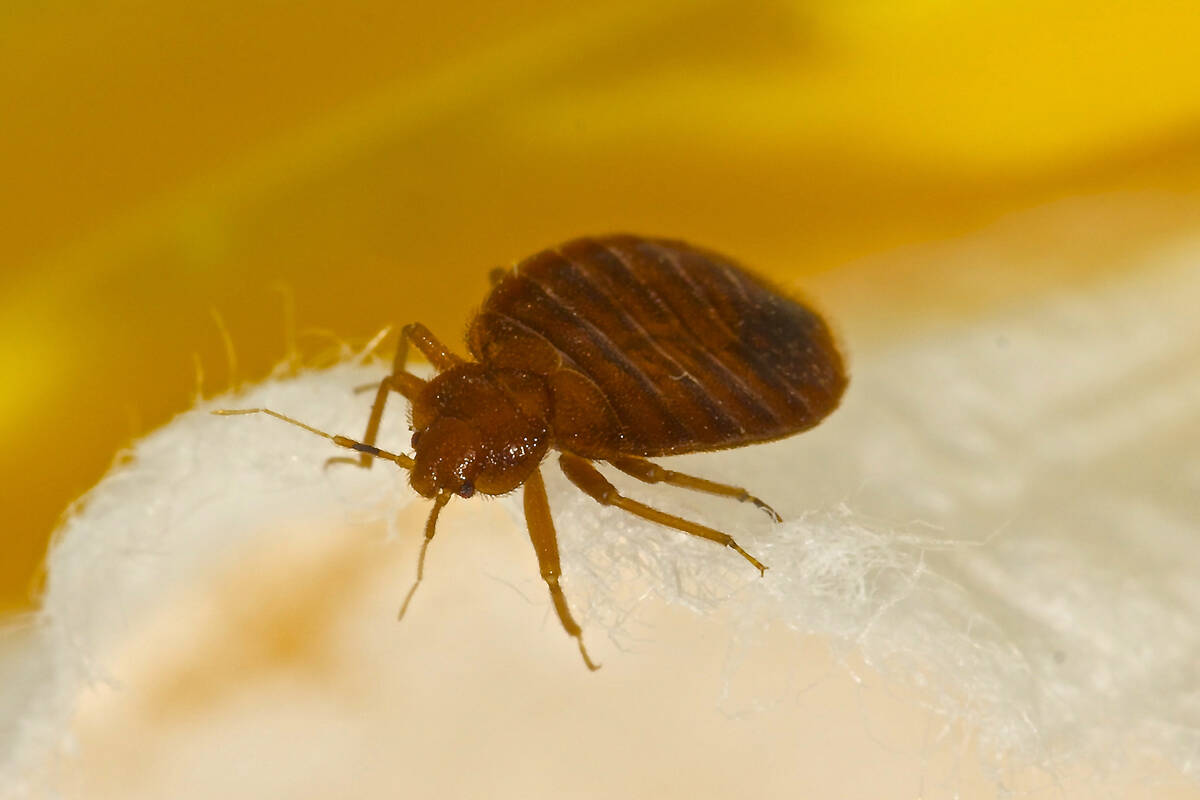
<box><xmin>217</xmin><ymin>235</ymin><xmax>847</xmax><ymax>669</ymax></box>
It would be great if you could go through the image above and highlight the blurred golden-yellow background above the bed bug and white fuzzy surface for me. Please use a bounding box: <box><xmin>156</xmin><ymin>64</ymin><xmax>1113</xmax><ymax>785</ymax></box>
<box><xmin>0</xmin><ymin>0</ymin><xmax>1200</xmax><ymax>608</ymax></box>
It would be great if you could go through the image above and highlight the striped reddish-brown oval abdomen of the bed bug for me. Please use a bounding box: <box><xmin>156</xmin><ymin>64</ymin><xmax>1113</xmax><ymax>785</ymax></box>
<box><xmin>469</xmin><ymin>236</ymin><xmax>846</xmax><ymax>456</ymax></box>
